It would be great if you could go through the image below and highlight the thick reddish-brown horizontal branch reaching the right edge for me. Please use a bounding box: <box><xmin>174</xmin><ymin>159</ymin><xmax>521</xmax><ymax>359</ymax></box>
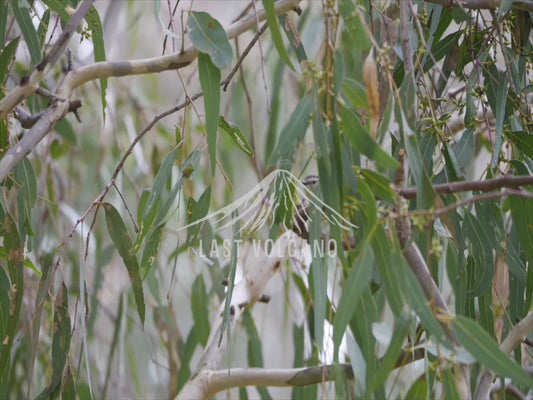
<box><xmin>396</xmin><ymin>175</ymin><xmax>533</xmax><ymax>199</ymax></box>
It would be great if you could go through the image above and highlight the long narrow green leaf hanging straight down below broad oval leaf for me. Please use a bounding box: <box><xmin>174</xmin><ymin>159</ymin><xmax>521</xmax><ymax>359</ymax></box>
<box><xmin>198</xmin><ymin>53</ymin><xmax>221</xmax><ymax>175</ymax></box>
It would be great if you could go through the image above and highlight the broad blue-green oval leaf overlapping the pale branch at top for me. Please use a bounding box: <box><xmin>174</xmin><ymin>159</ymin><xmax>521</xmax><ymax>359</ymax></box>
<box><xmin>187</xmin><ymin>11</ymin><xmax>233</xmax><ymax>69</ymax></box>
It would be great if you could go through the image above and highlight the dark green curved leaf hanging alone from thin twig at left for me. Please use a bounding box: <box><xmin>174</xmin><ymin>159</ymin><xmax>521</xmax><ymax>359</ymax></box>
<box><xmin>102</xmin><ymin>203</ymin><xmax>145</xmax><ymax>325</ymax></box>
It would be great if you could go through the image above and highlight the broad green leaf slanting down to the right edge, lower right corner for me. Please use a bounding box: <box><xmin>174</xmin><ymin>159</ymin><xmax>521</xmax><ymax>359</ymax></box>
<box><xmin>453</xmin><ymin>315</ymin><xmax>533</xmax><ymax>387</ymax></box>
